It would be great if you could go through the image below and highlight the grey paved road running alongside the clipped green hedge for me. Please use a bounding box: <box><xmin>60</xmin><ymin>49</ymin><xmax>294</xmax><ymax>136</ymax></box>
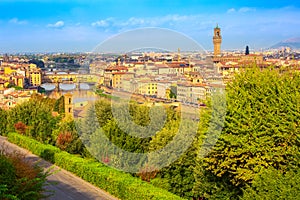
<box><xmin>0</xmin><ymin>136</ymin><xmax>117</xmax><ymax>200</ymax></box>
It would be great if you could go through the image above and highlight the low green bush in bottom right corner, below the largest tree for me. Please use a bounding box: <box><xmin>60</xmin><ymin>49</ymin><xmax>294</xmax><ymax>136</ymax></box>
<box><xmin>241</xmin><ymin>168</ymin><xmax>300</xmax><ymax>200</ymax></box>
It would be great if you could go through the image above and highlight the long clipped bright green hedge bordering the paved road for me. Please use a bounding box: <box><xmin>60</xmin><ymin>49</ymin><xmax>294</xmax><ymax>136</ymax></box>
<box><xmin>8</xmin><ymin>133</ymin><xmax>182</xmax><ymax>200</ymax></box>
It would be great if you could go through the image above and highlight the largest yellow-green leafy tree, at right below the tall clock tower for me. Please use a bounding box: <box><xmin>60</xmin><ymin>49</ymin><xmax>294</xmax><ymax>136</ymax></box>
<box><xmin>204</xmin><ymin>68</ymin><xmax>300</xmax><ymax>188</ymax></box>
